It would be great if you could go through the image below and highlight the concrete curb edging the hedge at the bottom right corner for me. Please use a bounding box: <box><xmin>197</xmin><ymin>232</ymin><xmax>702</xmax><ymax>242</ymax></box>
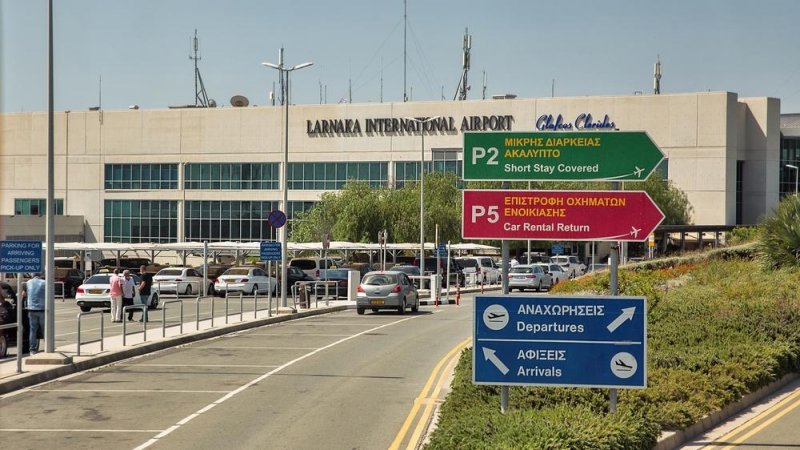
<box><xmin>653</xmin><ymin>373</ymin><xmax>800</xmax><ymax>450</ymax></box>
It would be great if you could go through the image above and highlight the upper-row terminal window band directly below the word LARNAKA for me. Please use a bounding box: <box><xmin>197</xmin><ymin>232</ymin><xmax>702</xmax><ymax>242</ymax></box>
<box><xmin>288</xmin><ymin>162</ymin><xmax>389</xmax><ymax>190</ymax></box>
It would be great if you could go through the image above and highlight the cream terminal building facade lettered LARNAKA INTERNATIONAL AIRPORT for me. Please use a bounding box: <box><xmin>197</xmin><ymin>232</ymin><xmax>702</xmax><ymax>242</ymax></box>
<box><xmin>0</xmin><ymin>92</ymin><xmax>784</xmax><ymax>246</ymax></box>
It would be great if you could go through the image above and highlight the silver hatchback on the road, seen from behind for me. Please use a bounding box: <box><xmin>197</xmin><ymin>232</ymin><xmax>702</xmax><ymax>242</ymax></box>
<box><xmin>356</xmin><ymin>270</ymin><xmax>419</xmax><ymax>314</ymax></box>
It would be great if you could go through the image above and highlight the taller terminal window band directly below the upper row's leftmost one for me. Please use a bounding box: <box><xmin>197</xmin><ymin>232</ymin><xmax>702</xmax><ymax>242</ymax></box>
<box><xmin>103</xmin><ymin>200</ymin><xmax>178</xmax><ymax>243</ymax></box>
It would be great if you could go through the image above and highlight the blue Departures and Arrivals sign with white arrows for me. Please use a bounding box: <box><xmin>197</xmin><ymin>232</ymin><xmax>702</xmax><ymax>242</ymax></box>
<box><xmin>472</xmin><ymin>296</ymin><xmax>647</xmax><ymax>388</ymax></box>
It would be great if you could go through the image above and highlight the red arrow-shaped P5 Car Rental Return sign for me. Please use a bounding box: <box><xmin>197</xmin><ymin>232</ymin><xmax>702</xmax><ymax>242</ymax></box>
<box><xmin>462</xmin><ymin>190</ymin><xmax>664</xmax><ymax>242</ymax></box>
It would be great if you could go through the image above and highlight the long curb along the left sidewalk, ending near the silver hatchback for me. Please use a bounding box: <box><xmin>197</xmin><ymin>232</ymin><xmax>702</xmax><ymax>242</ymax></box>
<box><xmin>0</xmin><ymin>305</ymin><xmax>352</xmax><ymax>395</ymax></box>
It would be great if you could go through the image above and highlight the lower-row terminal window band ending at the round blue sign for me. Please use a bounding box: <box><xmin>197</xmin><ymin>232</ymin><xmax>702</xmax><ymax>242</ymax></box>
<box><xmin>184</xmin><ymin>200</ymin><xmax>278</xmax><ymax>242</ymax></box>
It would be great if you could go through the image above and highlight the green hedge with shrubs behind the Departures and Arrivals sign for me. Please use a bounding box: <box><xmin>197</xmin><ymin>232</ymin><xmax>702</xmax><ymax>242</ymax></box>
<box><xmin>427</xmin><ymin>255</ymin><xmax>800</xmax><ymax>449</ymax></box>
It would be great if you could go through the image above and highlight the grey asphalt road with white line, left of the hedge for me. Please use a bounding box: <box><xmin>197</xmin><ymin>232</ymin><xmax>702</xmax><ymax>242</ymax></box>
<box><xmin>0</xmin><ymin>295</ymin><xmax>500</xmax><ymax>450</ymax></box>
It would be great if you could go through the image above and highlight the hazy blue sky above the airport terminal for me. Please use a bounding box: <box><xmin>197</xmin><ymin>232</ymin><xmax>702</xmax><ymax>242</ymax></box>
<box><xmin>0</xmin><ymin>0</ymin><xmax>800</xmax><ymax>113</ymax></box>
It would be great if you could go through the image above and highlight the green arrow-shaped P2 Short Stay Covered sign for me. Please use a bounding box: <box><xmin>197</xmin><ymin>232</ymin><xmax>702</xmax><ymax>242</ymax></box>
<box><xmin>464</xmin><ymin>131</ymin><xmax>664</xmax><ymax>181</ymax></box>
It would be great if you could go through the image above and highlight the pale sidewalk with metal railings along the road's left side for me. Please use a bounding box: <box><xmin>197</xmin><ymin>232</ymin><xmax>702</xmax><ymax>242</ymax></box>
<box><xmin>0</xmin><ymin>286</ymin><xmax>499</xmax><ymax>395</ymax></box>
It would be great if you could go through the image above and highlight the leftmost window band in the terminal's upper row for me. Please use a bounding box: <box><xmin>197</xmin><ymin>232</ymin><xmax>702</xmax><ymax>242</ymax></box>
<box><xmin>105</xmin><ymin>164</ymin><xmax>178</xmax><ymax>190</ymax></box>
